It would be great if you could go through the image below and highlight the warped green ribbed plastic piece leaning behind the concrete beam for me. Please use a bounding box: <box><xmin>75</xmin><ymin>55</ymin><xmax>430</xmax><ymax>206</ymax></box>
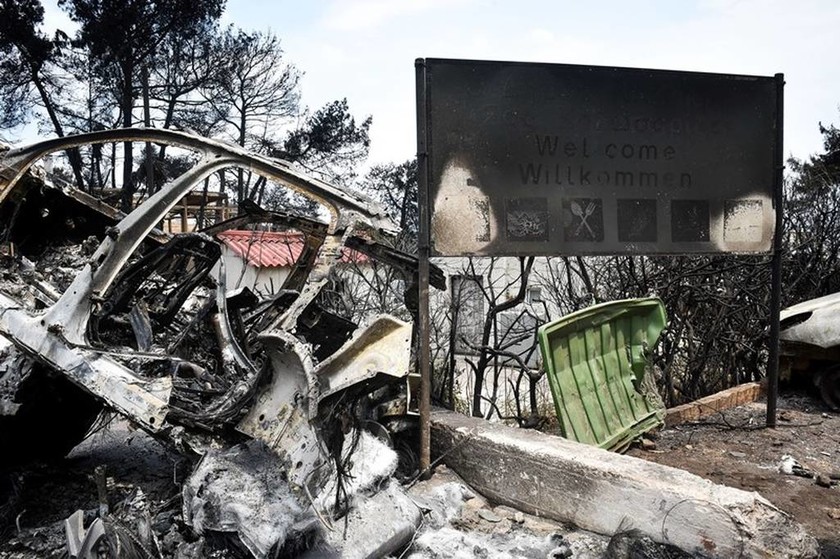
<box><xmin>538</xmin><ymin>298</ymin><xmax>667</xmax><ymax>452</ymax></box>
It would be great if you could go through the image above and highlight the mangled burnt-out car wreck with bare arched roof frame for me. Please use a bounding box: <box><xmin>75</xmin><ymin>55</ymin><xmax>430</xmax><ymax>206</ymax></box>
<box><xmin>0</xmin><ymin>129</ymin><xmax>443</xmax><ymax>557</ymax></box>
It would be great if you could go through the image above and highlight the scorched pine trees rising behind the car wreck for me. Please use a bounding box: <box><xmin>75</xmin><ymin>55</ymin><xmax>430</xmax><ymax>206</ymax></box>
<box><xmin>0</xmin><ymin>0</ymin><xmax>372</xmax><ymax>213</ymax></box>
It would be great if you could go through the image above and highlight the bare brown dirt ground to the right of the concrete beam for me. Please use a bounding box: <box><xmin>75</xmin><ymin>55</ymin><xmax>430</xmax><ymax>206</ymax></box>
<box><xmin>628</xmin><ymin>395</ymin><xmax>840</xmax><ymax>557</ymax></box>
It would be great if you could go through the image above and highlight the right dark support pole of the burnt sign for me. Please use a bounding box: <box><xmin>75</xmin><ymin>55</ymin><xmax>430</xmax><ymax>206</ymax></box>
<box><xmin>767</xmin><ymin>74</ymin><xmax>785</xmax><ymax>427</ymax></box>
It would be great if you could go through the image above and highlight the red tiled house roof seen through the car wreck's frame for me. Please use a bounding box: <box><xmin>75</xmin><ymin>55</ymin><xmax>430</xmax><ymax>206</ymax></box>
<box><xmin>217</xmin><ymin>230</ymin><xmax>368</xmax><ymax>268</ymax></box>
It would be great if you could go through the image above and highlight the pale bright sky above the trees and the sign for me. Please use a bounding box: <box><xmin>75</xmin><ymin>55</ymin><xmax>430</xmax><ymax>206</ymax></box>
<box><xmin>37</xmin><ymin>0</ymin><xmax>840</xmax><ymax>164</ymax></box>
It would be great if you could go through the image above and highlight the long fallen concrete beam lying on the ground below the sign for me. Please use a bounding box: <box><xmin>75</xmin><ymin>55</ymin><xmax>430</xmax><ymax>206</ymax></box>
<box><xmin>432</xmin><ymin>410</ymin><xmax>818</xmax><ymax>558</ymax></box>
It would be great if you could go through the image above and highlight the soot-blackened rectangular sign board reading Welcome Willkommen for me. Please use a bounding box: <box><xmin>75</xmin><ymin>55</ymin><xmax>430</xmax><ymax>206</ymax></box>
<box><xmin>418</xmin><ymin>59</ymin><xmax>781</xmax><ymax>256</ymax></box>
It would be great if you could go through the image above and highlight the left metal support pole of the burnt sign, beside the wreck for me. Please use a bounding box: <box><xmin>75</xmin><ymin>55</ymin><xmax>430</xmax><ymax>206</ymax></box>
<box><xmin>414</xmin><ymin>58</ymin><xmax>432</xmax><ymax>479</ymax></box>
